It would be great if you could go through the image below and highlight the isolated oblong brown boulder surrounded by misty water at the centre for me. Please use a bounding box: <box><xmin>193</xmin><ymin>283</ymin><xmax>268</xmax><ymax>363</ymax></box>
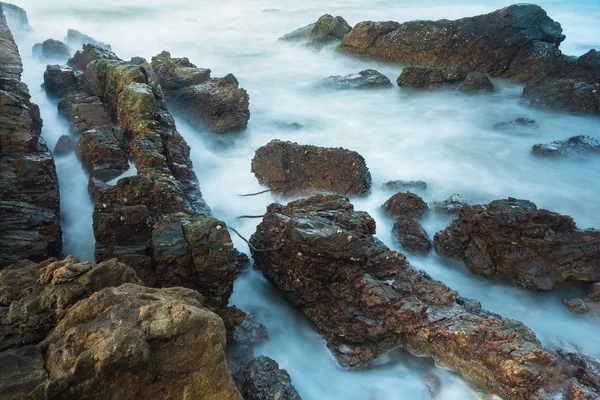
<box><xmin>252</xmin><ymin>140</ymin><xmax>371</xmax><ymax>196</ymax></box>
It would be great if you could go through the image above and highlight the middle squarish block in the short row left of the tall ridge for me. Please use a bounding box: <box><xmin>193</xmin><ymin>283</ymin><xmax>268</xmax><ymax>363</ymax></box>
<box><xmin>58</xmin><ymin>93</ymin><xmax>112</xmax><ymax>134</ymax></box>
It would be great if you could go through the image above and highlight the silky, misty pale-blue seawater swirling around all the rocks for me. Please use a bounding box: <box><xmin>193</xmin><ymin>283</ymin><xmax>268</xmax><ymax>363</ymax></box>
<box><xmin>9</xmin><ymin>0</ymin><xmax>600</xmax><ymax>400</ymax></box>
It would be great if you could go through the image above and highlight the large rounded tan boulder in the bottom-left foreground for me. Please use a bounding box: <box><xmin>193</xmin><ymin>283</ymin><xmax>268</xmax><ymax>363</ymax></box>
<box><xmin>36</xmin><ymin>284</ymin><xmax>241</xmax><ymax>400</ymax></box>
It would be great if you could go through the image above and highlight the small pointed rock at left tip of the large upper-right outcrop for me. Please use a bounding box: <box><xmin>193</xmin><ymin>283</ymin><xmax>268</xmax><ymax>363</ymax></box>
<box><xmin>279</xmin><ymin>14</ymin><xmax>352</xmax><ymax>48</ymax></box>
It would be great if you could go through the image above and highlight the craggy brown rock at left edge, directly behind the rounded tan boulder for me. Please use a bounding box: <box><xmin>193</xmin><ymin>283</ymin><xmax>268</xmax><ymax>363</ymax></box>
<box><xmin>0</xmin><ymin>256</ymin><xmax>139</xmax><ymax>351</ymax></box>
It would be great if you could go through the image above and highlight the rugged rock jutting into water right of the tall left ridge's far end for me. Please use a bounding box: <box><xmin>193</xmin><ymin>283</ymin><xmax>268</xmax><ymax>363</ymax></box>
<box><xmin>152</xmin><ymin>51</ymin><xmax>250</xmax><ymax>133</ymax></box>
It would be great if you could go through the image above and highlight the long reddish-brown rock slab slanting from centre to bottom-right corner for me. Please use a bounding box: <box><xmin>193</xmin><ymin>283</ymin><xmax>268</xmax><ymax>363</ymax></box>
<box><xmin>250</xmin><ymin>195</ymin><xmax>599</xmax><ymax>399</ymax></box>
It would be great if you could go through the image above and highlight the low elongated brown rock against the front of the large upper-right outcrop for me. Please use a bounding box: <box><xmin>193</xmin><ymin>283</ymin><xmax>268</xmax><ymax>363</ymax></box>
<box><xmin>397</xmin><ymin>67</ymin><xmax>468</xmax><ymax>89</ymax></box>
